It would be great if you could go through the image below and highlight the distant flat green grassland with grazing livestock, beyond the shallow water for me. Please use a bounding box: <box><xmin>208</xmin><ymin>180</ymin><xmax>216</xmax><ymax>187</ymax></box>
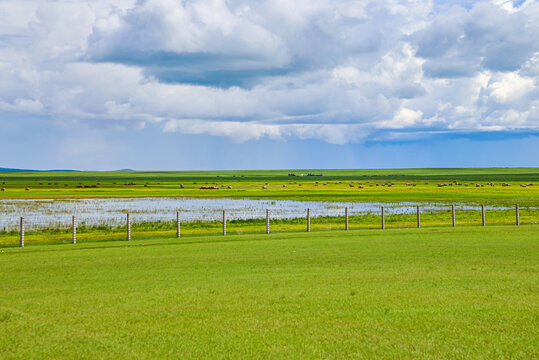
<box><xmin>0</xmin><ymin>168</ymin><xmax>539</xmax><ymax>206</ymax></box>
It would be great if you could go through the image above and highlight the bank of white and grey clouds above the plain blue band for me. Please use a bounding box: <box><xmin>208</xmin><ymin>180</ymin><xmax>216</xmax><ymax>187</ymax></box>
<box><xmin>0</xmin><ymin>0</ymin><xmax>539</xmax><ymax>144</ymax></box>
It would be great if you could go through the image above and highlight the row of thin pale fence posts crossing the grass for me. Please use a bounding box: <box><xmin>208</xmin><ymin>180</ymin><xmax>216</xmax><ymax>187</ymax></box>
<box><xmin>6</xmin><ymin>204</ymin><xmax>532</xmax><ymax>247</ymax></box>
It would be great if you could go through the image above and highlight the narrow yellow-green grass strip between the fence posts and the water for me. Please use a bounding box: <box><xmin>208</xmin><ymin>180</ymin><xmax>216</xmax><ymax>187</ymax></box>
<box><xmin>0</xmin><ymin>208</ymin><xmax>539</xmax><ymax>247</ymax></box>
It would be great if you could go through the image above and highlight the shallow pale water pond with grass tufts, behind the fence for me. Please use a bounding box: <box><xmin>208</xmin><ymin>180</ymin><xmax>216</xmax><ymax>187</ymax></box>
<box><xmin>0</xmin><ymin>197</ymin><xmax>520</xmax><ymax>231</ymax></box>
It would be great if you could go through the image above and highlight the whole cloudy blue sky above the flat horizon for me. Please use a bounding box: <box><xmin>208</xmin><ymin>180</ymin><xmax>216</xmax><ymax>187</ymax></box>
<box><xmin>0</xmin><ymin>0</ymin><xmax>539</xmax><ymax>170</ymax></box>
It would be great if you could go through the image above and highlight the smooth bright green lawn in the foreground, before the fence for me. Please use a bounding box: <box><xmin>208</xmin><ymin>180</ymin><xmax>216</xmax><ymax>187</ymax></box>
<box><xmin>0</xmin><ymin>226</ymin><xmax>539</xmax><ymax>359</ymax></box>
